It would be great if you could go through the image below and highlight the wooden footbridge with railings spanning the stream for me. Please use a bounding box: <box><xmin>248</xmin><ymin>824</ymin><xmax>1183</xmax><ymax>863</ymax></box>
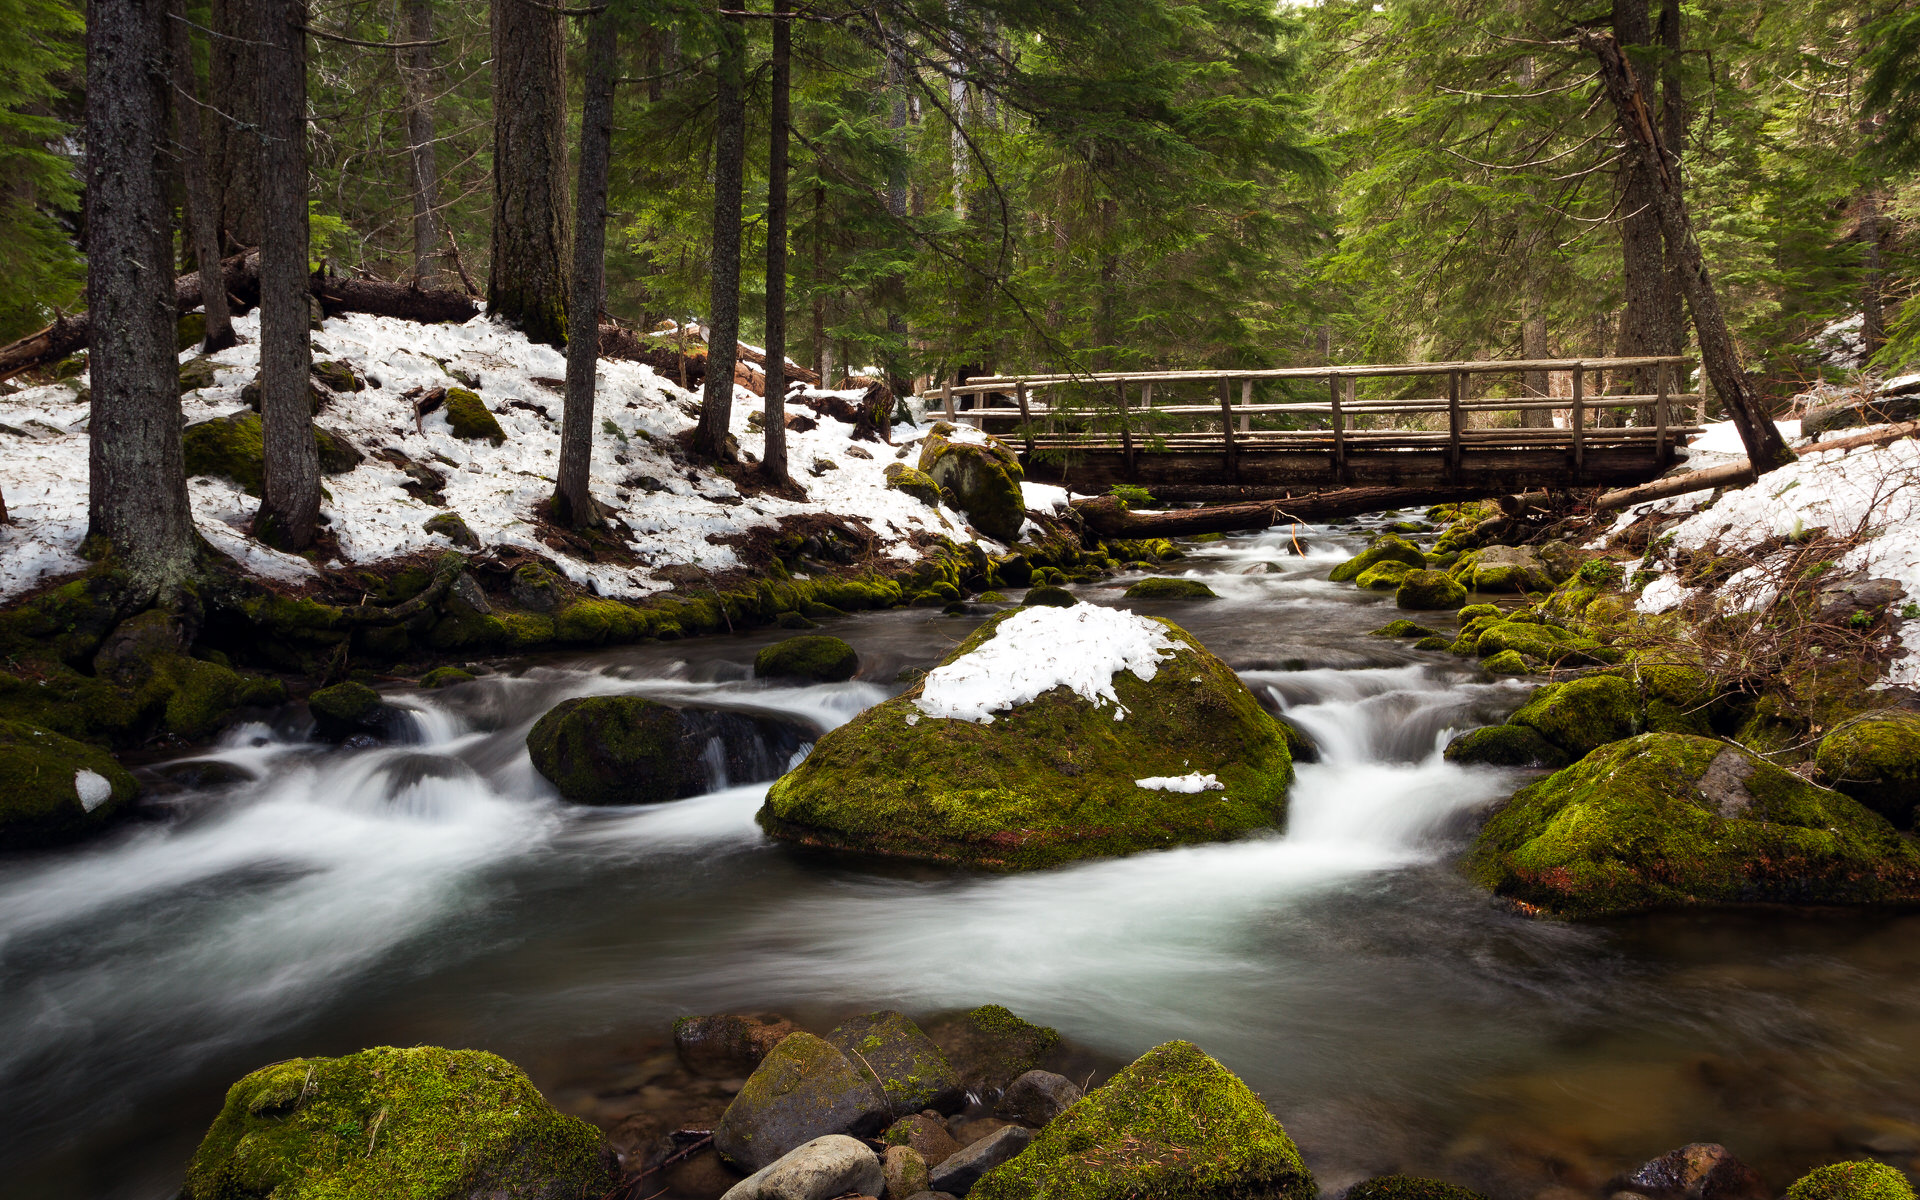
<box><xmin>939</xmin><ymin>355</ymin><xmax>1701</xmax><ymax>497</ymax></box>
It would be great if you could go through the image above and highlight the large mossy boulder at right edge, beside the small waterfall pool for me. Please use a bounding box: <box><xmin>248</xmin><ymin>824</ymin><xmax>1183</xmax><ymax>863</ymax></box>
<box><xmin>1469</xmin><ymin>733</ymin><xmax>1920</xmax><ymax>918</ymax></box>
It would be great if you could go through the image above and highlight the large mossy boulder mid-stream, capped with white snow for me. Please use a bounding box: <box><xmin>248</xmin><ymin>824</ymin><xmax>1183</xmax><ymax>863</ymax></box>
<box><xmin>758</xmin><ymin>605</ymin><xmax>1292</xmax><ymax>870</ymax></box>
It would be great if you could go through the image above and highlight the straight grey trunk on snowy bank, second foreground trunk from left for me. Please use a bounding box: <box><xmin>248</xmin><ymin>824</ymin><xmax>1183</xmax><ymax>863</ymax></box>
<box><xmin>253</xmin><ymin>0</ymin><xmax>321</xmax><ymax>549</ymax></box>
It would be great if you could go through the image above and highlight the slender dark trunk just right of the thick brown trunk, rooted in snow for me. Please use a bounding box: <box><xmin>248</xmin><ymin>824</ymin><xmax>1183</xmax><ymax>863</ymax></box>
<box><xmin>556</xmin><ymin>0</ymin><xmax>620</xmax><ymax>526</ymax></box>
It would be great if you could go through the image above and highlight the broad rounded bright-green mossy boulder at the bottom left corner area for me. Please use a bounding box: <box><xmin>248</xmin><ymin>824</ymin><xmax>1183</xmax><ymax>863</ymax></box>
<box><xmin>180</xmin><ymin>1046</ymin><xmax>614</xmax><ymax>1200</ymax></box>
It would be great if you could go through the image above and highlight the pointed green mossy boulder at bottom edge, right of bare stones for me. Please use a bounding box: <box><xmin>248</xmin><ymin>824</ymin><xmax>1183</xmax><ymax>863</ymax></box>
<box><xmin>968</xmin><ymin>1043</ymin><xmax>1315</xmax><ymax>1200</ymax></box>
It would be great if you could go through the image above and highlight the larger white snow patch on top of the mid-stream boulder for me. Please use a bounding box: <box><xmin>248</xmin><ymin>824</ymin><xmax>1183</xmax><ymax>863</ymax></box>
<box><xmin>914</xmin><ymin>605</ymin><xmax>1175</xmax><ymax>724</ymax></box>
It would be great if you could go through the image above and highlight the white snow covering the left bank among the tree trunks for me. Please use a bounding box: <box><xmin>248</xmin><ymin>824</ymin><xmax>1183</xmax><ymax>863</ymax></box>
<box><xmin>0</xmin><ymin>315</ymin><xmax>1013</xmax><ymax>599</ymax></box>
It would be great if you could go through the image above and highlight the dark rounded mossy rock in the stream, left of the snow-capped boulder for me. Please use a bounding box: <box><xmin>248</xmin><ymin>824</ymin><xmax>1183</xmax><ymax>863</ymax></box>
<box><xmin>526</xmin><ymin>695</ymin><xmax>707</xmax><ymax>804</ymax></box>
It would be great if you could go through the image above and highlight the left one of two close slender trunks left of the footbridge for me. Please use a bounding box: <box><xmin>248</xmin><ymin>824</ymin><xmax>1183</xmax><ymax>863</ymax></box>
<box><xmin>693</xmin><ymin>9</ymin><xmax>747</xmax><ymax>459</ymax></box>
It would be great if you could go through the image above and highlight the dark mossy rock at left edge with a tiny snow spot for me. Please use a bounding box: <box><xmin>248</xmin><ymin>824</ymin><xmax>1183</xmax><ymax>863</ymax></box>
<box><xmin>0</xmin><ymin>720</ymin><xmax>140</xmax><ymax>851</ymax></box>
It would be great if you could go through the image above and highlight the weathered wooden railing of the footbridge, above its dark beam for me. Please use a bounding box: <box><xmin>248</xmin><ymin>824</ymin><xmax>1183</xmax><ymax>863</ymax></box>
<box><xmin>939</xmin><ymin>355</ymin><xmax>1701</xmax><ymax>470</ymax></box>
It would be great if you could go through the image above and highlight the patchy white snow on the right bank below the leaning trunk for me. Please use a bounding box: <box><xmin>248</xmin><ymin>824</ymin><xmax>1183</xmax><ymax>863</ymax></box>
<box><xmin>1596</xmin><ymin>422</ymin><xmax>1920</xmax><ymax>687</ymax></box>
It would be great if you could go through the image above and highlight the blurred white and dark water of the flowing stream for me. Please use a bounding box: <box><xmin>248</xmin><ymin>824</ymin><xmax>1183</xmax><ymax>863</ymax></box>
<box><xmin>0</xmin><ymin>528</ymin><xmax>1920</xmax><ymax>1200</ymax></box>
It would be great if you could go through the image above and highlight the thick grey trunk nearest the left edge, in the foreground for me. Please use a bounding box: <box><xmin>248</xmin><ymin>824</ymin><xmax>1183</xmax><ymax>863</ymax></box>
<box><xmin>86</xmin><ymin>0</ymin><xmax>198</xmax><ymax>599</ymax></box>
